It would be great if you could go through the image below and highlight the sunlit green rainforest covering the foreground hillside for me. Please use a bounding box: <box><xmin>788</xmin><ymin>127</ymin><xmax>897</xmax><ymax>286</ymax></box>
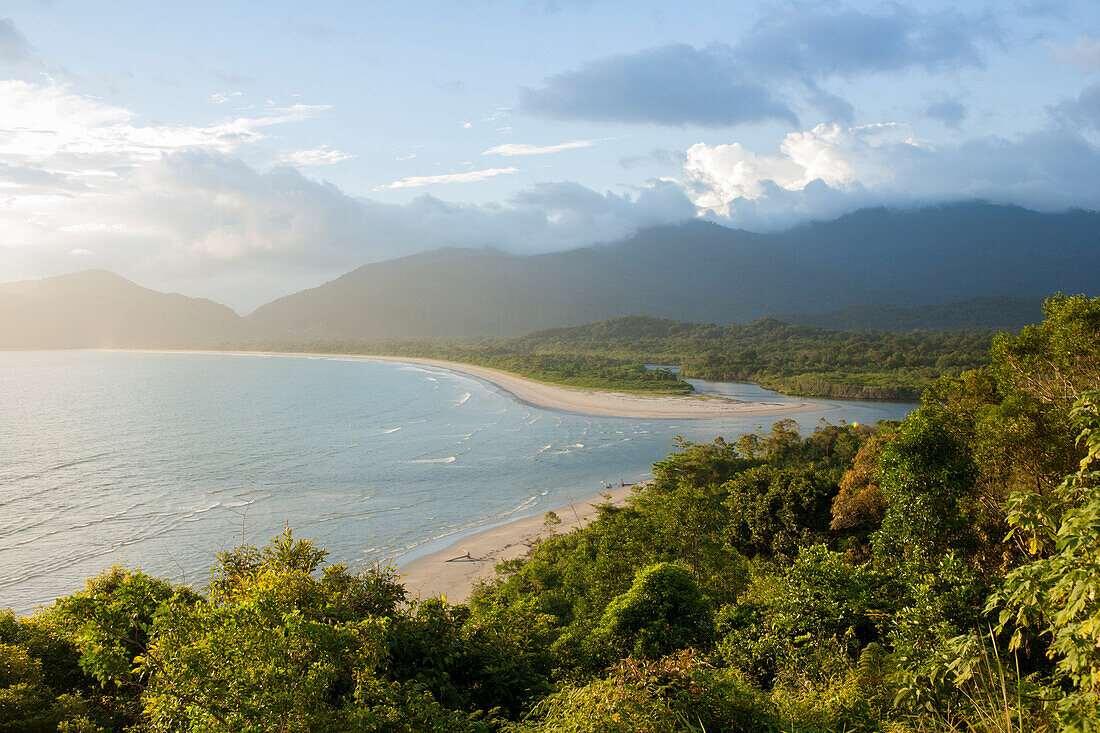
<box><xmin>0</xmin><ymin>296</ymin><xmax>1100</xmax><ymax>733</ymax></box>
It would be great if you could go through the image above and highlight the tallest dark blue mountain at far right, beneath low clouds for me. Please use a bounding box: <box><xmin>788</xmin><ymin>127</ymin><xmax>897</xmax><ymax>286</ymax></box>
<box><xmin>769</xmin><ymin>203</ymin><xmax>1100</xmax><ymax>303</ymax></box>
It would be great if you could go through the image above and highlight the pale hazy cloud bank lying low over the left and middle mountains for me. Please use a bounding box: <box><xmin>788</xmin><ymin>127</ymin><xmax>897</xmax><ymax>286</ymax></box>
<box><xmin>0</xmin><ymin>151</ymin><xmax>695</xmax><ymax>310</ymax></box>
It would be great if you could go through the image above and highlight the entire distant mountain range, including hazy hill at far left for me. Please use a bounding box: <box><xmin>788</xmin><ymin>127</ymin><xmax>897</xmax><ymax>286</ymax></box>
<box><xmin>0</xmin><ymin>204</ymin><xmax>1100</xmax><ymax>348</ymax></box>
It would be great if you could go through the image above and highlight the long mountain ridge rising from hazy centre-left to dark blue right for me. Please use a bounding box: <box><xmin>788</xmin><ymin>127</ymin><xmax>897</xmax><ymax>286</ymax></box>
<box><xmin>246</xmin><ymin>204</ymin><xmax>1100</xmax><ymax>339</ymax></box>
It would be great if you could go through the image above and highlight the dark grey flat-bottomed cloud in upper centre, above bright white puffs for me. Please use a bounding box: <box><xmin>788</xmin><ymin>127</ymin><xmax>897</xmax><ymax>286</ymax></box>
<box><xmin>519</xmin><ymin>44</ymin><xmax>798</xmax><ymax>128</ymax></box>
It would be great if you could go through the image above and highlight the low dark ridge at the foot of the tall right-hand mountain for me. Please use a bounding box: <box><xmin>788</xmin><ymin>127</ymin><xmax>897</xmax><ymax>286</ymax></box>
<box><xmin>776</xmin><ymin>296</ymin><xmax>1043</xmax><ymax>331</ymax></box>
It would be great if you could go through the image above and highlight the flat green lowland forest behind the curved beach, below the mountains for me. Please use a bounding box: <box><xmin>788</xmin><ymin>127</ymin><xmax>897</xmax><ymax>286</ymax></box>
<box><xmin>245</xmin><ymin>316</ymin><xmax>991</xmax><ymax>401</ymax></box>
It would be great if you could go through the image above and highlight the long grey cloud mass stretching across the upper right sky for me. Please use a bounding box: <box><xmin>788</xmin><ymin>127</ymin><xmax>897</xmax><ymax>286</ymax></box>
<box><xmin>519</xmin><ymin>2</ymin><xmax>1000</xmax><ymax>128</ymax></box>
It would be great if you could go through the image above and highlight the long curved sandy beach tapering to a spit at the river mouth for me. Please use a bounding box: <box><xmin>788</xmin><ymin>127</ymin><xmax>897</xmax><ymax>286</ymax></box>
<box><xmin>116</xmin><ymin>349</ymin><xmax>817</xmax><ymax>419</ymax></box>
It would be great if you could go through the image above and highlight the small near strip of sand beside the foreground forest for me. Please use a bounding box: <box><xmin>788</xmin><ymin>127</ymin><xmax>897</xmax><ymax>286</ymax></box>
<box><xmin>400</xmin><ymin>485</ymin><xmax>635</xmax><ymax>603</ymax></box>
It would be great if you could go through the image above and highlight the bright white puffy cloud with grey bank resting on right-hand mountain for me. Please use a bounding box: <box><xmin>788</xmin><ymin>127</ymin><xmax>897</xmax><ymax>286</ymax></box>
<box><xmin>680</xmin><ymin>123</ymin><xmax>1100</xmax><ymax>229</ymax></box>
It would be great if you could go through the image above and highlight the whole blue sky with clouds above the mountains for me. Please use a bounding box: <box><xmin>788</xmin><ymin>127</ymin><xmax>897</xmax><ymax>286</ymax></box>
<box><xmin>0</xmin><ymin>0</ymin><xmax>1100</xmax><ymax>314</ymax></box>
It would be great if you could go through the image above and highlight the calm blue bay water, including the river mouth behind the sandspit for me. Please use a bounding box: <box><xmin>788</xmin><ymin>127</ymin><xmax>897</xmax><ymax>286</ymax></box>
<box><xmin>0</xmin><ymin>351</ymin><xmax>912</xmax><ymax>613</ymax></box>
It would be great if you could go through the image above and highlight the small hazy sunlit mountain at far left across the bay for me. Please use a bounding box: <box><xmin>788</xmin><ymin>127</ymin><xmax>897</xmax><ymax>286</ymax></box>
<box><xmin>0</xmin><ymin>270</ymin><xmax>245</xmax><ymax>349</ymax></box>
